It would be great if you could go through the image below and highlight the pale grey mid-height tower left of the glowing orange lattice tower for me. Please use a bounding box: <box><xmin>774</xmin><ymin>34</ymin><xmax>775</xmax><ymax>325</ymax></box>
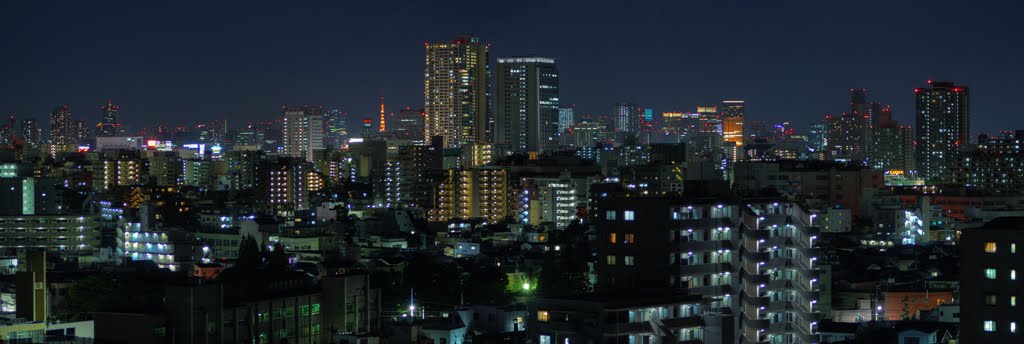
<box><xmin>281</xmin><ymin>106</ymin><xmax>324</xmax><ymax>161</ymax></box>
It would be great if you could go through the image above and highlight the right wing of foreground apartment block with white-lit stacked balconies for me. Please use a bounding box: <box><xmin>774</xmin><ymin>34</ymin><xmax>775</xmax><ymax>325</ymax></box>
<box><xmin>737</xmin><ymin>202</ymin><xmax>830</xmax><ymax>344</ymax></box>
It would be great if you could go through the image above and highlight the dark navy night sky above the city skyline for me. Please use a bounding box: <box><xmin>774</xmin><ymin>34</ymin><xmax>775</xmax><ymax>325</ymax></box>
<box><xmin>0</xmin><ymin>0</ymin><xmax>1024</xmax><ymax>136</ymax></box>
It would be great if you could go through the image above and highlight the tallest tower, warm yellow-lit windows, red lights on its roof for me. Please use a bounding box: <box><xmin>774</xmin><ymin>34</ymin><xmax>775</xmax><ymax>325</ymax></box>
<box><xmin>423</xmin><ymin>36</ymin><xmax>490</xmax><ymax>147</ymax></box>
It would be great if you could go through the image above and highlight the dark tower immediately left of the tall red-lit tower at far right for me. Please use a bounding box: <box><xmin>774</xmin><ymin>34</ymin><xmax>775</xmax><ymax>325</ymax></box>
<box><xmin>867</xmin><ymin>106</ymin><xmax>914</xmax><ymax>174</ymax></box>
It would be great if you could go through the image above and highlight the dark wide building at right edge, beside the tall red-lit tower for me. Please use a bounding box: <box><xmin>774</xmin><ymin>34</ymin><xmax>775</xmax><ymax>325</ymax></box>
<box><xmin>956</xmin><ymin>130</ymin><xmax>1024</xmax><ymax>196</ymax></box>
